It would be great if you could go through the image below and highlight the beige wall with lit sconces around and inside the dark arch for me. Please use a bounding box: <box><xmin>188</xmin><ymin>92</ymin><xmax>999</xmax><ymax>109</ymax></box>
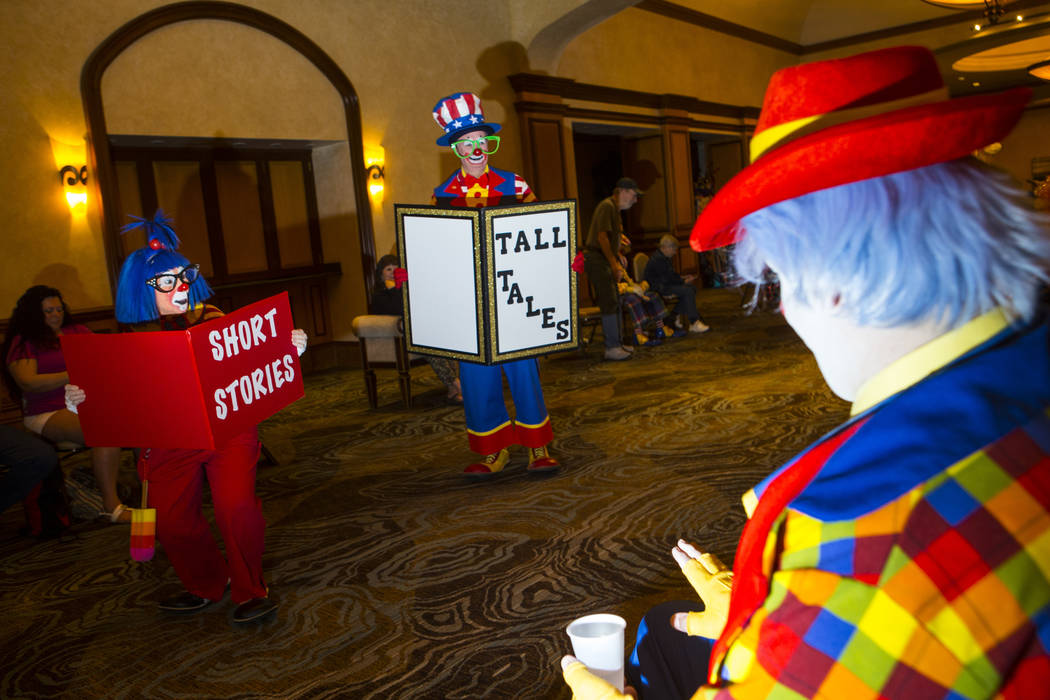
<box><xmin>0</xmin><ymin>0</ymin><xmax>579</xmax><ymax>326</ymax></box>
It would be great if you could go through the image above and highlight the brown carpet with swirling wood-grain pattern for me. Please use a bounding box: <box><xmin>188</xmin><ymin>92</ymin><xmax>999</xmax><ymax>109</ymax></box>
<box><xmin>0</xmin><ymin>290</ymin><xmax>847</xmax><ymax>699</ymax></box>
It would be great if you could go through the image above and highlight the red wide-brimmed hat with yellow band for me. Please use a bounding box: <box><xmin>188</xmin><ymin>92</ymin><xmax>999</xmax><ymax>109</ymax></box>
<box><xmin>690</xmin><ymin>46</ymin><xmax>1031</xmax><ymax>252</ymax></box>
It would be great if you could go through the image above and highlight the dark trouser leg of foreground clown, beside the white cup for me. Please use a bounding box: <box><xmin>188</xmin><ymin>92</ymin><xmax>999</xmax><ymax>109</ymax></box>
<box><xmin>624</xmin><ymin>600</ymin><xmax>714</xmax><ymax>700</ymax></box>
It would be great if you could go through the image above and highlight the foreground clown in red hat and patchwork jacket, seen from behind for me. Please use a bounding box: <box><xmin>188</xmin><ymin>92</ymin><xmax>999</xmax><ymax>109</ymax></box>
<box><xmin>563</xmin><ymin>46</ymin><xmax>1050</xmax><ymax>700</ymax></box>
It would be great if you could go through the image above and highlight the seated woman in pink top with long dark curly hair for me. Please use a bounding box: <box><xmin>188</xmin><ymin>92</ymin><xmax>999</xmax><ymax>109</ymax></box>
<box><xmin>2</xmin><ymin>284</ymin><xmax>131</xmax><ymax>523</ymax></box>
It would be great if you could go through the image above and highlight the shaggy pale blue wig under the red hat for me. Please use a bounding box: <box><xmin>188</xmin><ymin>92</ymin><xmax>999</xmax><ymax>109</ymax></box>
<box><xmin>734</xmin><ymin>158</ymin><xmax>1050</xmax><ymax>328</ymax></box>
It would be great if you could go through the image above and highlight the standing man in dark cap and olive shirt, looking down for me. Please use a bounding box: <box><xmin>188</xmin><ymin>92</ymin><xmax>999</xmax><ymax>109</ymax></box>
<box><xmin>584</xmin><ymin>177</ymin><xmax>642</xmax><ymax>360</ymax></box>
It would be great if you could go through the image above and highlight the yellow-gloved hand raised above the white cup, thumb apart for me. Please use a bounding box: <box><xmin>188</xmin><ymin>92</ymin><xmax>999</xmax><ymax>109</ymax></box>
<box><xmin>671</xmin><ymin>539</ymin><xmax>733</xmax><ymax>639</ymax></box>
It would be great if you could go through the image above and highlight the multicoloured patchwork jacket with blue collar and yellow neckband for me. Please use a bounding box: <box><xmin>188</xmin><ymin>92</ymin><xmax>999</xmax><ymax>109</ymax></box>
<box><xmin>694</xmin><ymin>311</ymin><xmax>1050</xmax><ymax>700</ymax></box>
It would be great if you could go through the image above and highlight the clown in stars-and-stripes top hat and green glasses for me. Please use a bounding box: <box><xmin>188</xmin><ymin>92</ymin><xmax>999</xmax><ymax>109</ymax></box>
<box><xmin>432</xmin><ymin>92</ymin><xmax>560</xmax><ymax>478</ymax></box>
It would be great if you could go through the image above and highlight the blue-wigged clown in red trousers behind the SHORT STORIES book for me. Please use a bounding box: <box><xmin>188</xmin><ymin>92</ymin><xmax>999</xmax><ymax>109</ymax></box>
<box><xmin>66</xmin><ymin>211</ymin><xmax>307</xmax><ymax>622</ymax></box>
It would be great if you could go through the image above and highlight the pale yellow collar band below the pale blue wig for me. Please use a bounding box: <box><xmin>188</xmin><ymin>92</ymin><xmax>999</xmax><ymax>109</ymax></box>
<box><xmin>849</xmin><ymin>309</ymin><xmax>1009</xmax><ymax>417</ymax></box>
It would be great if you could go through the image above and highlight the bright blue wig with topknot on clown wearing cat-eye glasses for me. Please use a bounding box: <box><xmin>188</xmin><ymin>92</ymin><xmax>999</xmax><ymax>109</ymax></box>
<box><xmin>117</xmin><ymin>209</ymin><xmax>212</xmax><ymax>323</ymax></box>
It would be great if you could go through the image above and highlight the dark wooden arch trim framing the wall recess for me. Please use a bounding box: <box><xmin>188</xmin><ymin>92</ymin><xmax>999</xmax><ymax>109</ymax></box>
<box><xmin>80</xmin><ymin>0</ymin><xmax>375</xmax><ymax>293</ymax></box>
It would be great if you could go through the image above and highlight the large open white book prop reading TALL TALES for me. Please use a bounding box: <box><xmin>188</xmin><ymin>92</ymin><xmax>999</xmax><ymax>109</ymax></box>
<box><xmin>394</xmin><ymin>200</ymin><xmax>580</xmax><ymax>364</ymax></box>
